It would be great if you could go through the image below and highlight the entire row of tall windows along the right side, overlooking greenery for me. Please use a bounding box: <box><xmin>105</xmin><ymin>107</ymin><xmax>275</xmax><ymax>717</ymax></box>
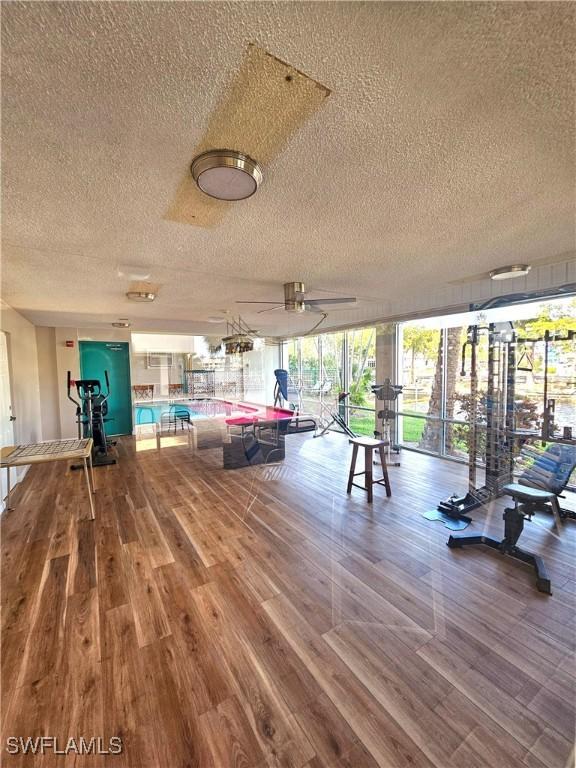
<box><xmin>284</xmin><ymin>299</ymin><xmax>576</xmax><ymax>448</ymax></box>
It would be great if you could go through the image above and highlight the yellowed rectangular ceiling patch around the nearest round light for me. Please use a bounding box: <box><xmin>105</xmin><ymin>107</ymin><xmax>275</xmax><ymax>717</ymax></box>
<box><xmin>164</xmin><ymin>43</ymin><xmax>330</xmax><ymax>227</ymax></box>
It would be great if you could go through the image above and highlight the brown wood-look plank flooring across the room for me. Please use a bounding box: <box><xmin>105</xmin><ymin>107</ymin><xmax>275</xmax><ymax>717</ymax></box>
<box><xmin>1</xmin><ymin>435</ymin><xmax>576</xmax><ymax>768</ymax></box>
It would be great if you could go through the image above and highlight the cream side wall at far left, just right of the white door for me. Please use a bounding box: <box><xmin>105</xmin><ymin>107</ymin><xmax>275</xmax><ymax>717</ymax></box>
<box><xmin>0</xmin><ymin>302</ymin><xmax>42</xmax><ymax>479</ymax></box>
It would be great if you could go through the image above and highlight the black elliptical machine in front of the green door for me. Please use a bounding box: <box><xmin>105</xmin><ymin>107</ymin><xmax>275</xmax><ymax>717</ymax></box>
<box><xmin>67</xmin><ymin>371</ymin><xmax>116</xmax><ymax>469</ymax></box>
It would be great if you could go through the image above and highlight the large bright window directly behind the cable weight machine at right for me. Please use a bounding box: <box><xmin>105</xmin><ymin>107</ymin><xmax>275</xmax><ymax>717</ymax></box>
<box><xmin>398</xmin><ymin>299</ymin><xmax>576</xmax><ymax>459</ymax></box>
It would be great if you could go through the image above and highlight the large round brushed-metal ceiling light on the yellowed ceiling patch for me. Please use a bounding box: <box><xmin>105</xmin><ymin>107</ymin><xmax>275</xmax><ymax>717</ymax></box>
<box><xmin>190</xmin><ymin>149</ymin><xmax>263</xmax><ymax>201</ymax></box>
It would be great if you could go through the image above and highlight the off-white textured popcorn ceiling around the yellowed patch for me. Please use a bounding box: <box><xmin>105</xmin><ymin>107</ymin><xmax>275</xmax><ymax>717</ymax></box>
<box><xmin>2</xmin><ymin>2</ymin><xmax>575</xmax><ymax>334</ymax></box>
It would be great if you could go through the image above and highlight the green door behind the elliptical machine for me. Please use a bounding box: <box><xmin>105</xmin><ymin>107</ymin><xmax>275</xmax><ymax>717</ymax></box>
<box><xmin>80</xmin><ymin>341</ymin><xmax>132</xmax><ymax>435</ymax></box>
